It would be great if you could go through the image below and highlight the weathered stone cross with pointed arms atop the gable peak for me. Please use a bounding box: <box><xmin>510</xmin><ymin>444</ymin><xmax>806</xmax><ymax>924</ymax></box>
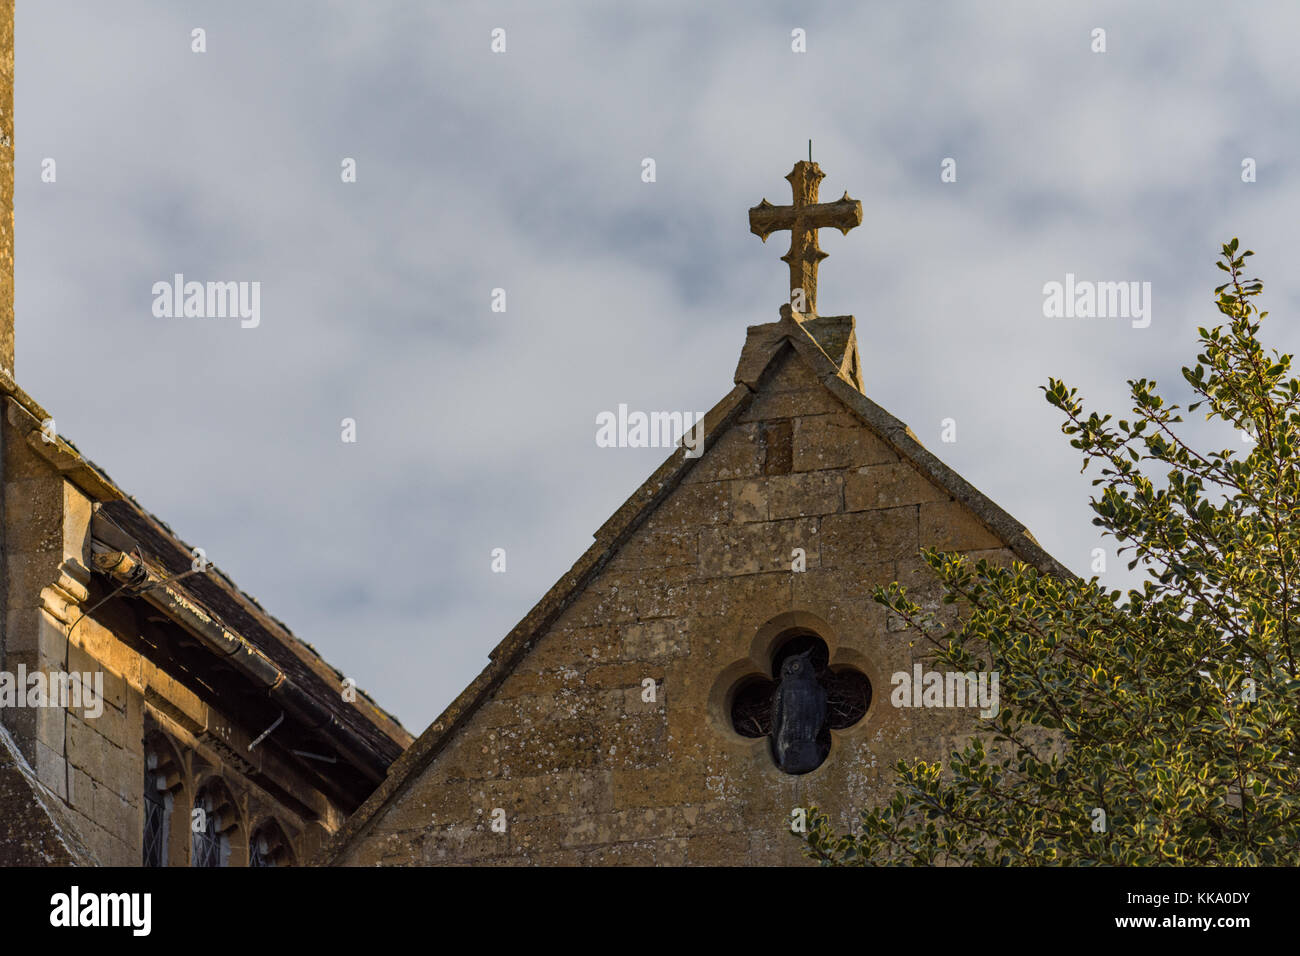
<box><xmin>749</xmin><ymin>160</ymin><xmax>862</xmax><ymax>316</ymax></box>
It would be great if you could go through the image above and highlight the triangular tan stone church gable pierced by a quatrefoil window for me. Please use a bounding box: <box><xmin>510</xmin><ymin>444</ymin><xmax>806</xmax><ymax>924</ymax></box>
<box><xmin>328</xmin><ymin>310</ymin><xmax>1050</xmax><ymax>865</ymax></box>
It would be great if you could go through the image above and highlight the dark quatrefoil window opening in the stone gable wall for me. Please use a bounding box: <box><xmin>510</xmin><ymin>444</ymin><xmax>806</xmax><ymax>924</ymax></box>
<box><xmin>731</xmin><ymin>630</ymin><xmax>871</xmax><ymax>774</ymax></box>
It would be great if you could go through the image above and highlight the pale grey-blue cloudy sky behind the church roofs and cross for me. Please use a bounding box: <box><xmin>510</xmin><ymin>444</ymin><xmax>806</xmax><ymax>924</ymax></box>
<box><xmin>16</xmin><ymin>0</ymin><xmax>1300</xmax><ymax>732</ymax></box>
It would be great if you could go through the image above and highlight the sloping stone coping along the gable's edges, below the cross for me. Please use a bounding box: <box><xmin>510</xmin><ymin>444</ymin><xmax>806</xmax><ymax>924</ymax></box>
<box><xmin>316</xmin><ymin>306</ymin><xmax>1071</xmax><ymax>864</ymax></box>
